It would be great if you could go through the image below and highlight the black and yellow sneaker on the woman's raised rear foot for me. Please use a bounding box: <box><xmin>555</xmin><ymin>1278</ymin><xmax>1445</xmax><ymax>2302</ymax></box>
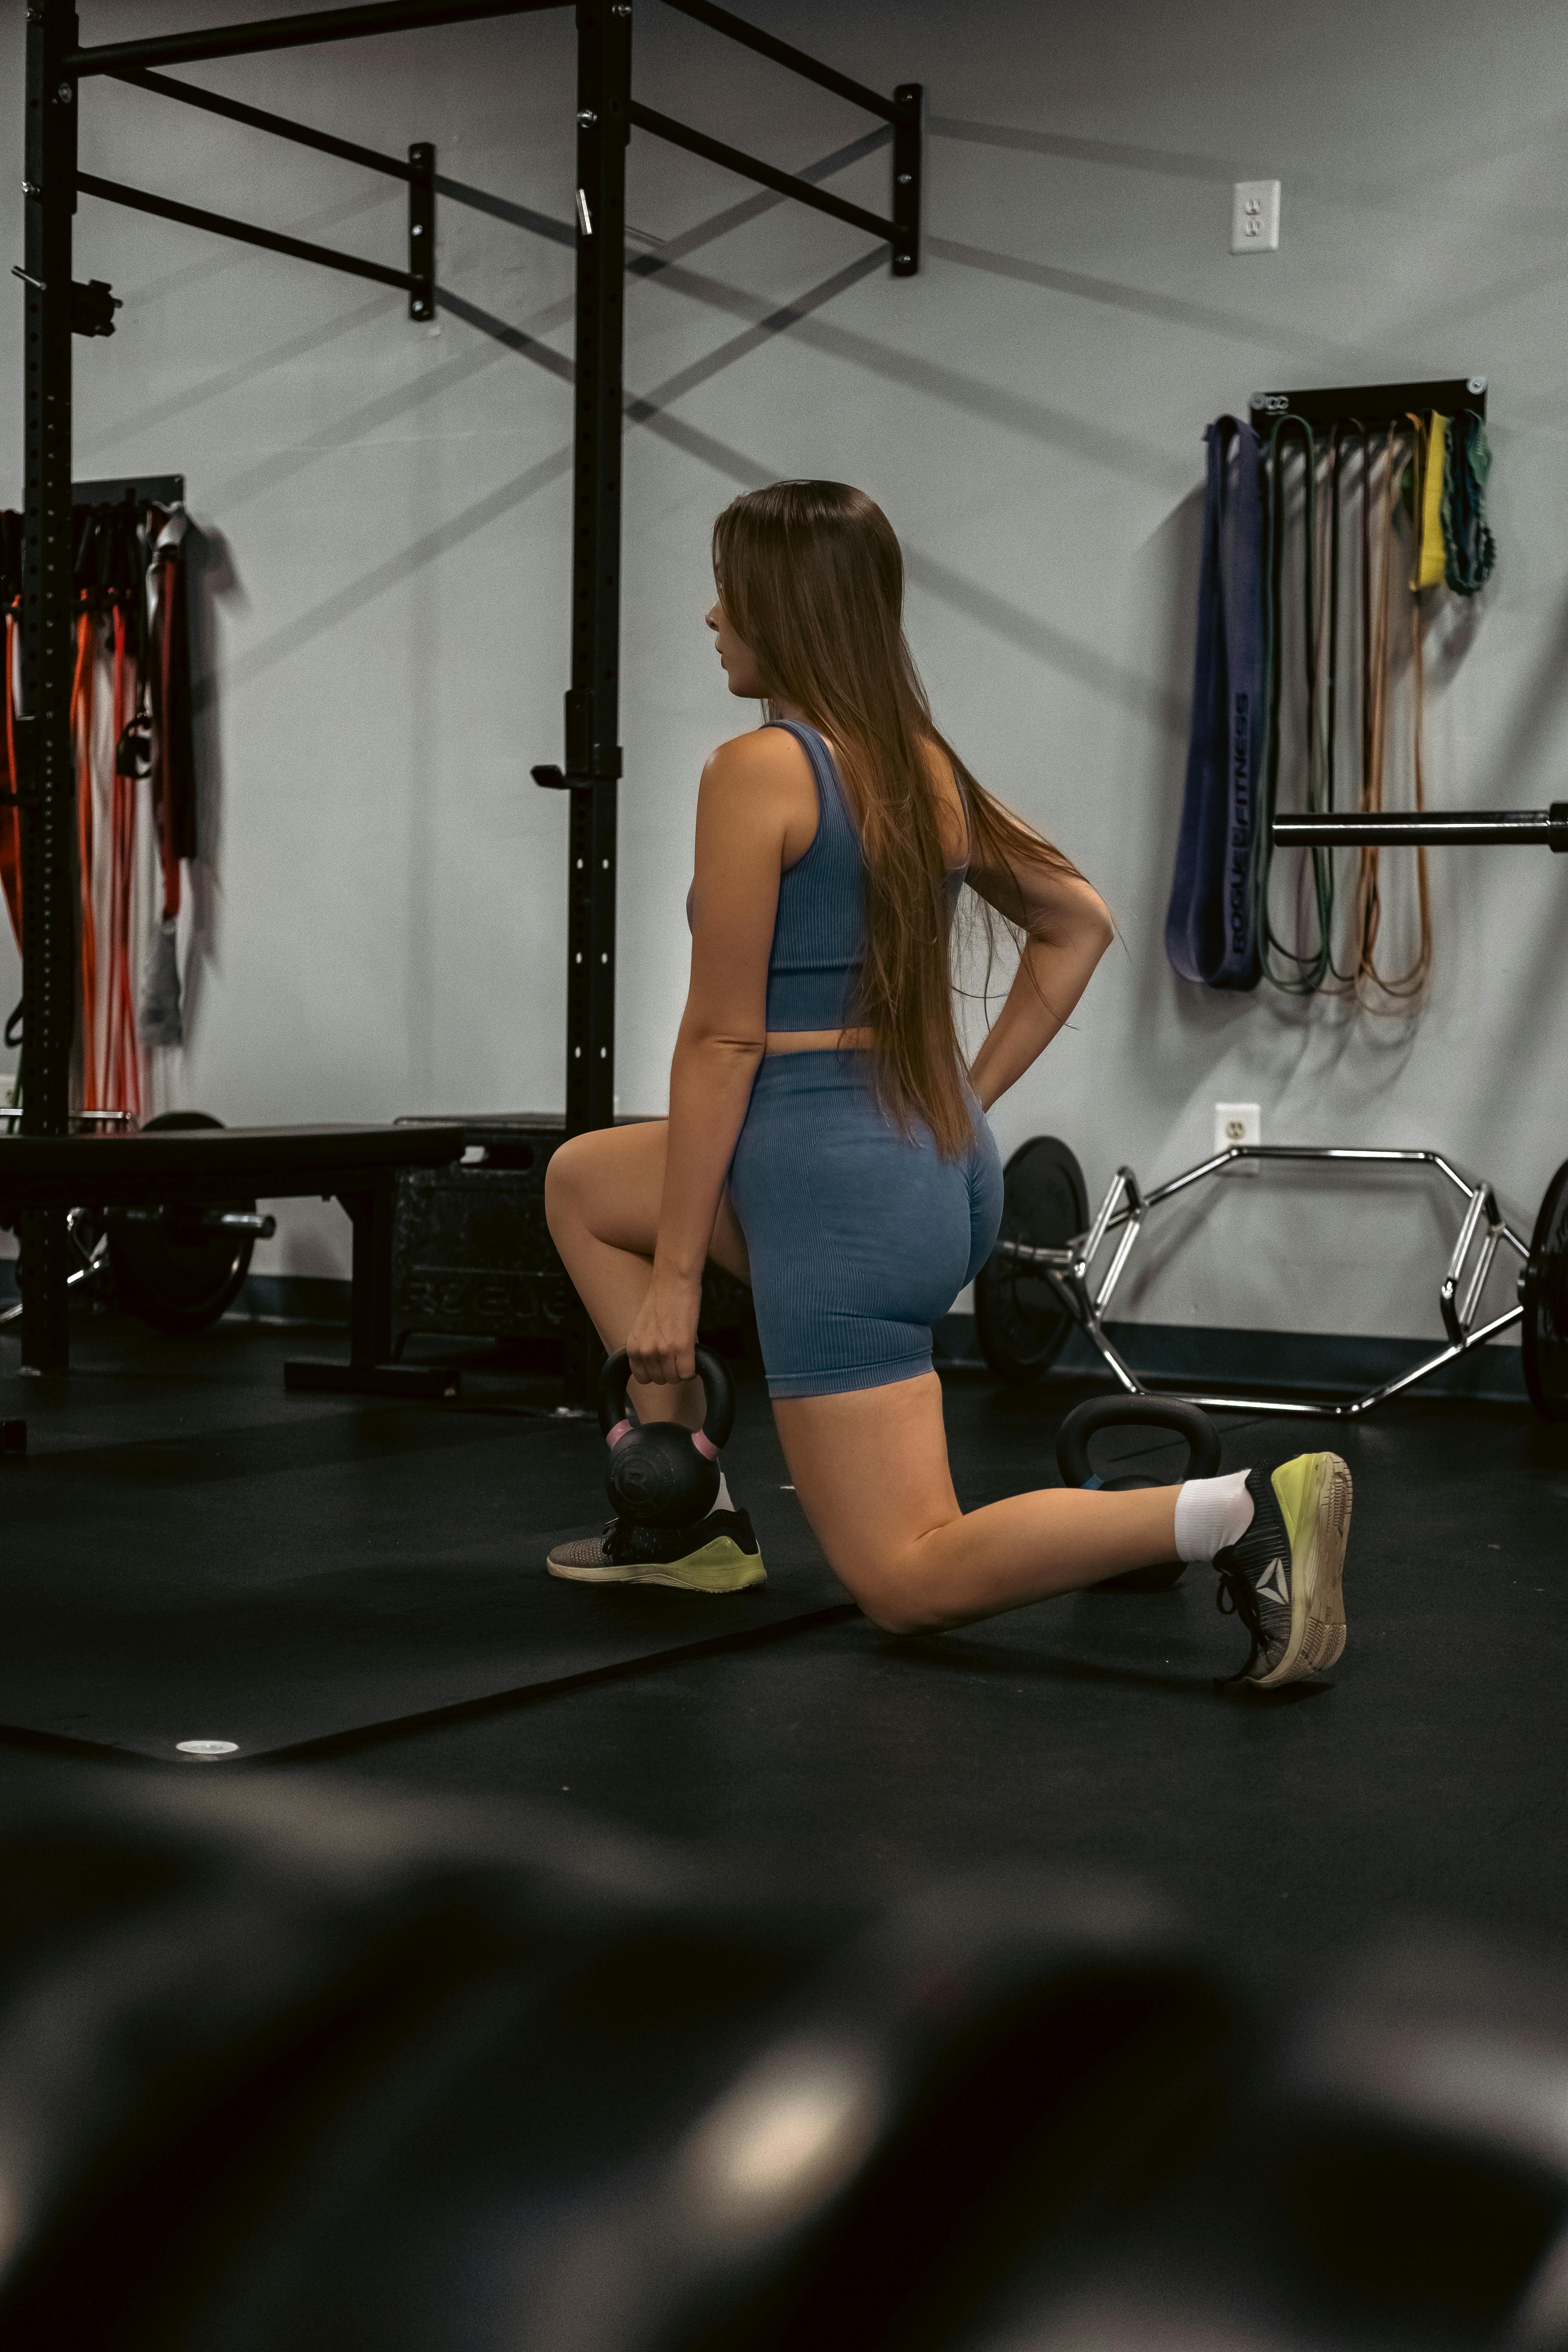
<box><xmin>1213</xmin><ymin>1453</ymin><xmax>1349</xmax><ymax>1691</ymax></box>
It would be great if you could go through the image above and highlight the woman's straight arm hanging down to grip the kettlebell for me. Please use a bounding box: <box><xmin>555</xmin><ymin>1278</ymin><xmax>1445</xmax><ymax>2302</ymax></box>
<box><xmin>625</xmin><ymin>729</ymin><xmax>799</xmax><ymax>1385</ymax></box>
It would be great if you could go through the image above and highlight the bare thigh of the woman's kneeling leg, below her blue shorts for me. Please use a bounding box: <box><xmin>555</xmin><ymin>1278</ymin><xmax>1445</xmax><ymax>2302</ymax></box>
<box><xmin>773</xmin><ymin>1371</ymin><xmax>959</xmax><ymax>1616</ymax></box>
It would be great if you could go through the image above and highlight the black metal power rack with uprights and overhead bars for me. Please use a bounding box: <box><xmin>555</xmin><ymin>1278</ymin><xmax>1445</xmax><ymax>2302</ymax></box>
<box><xmin>17</xmin><ymin>0</ymin><xmax>922</xmax><ymax>1388</ymax></box>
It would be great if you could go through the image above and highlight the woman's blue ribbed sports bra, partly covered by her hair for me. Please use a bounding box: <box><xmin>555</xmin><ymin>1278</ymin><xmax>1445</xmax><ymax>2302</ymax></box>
<box><xmin>766</xmin><ymin>720</ymin><xmax>966</xmax><ymax>1030</ymax></box>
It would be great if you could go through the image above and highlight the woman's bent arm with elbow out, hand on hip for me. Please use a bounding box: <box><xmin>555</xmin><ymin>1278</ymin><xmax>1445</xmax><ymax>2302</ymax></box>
<box><xmin>969</xmin><ymin>842</ymin><xmax>1117</xmax><ymax>1110</ymax></box>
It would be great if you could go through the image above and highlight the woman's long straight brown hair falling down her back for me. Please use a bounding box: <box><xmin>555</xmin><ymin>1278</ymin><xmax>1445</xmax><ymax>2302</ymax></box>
<box><xmin>712</xmin><ymin>482</ymin><xmax>1076</xmax><ymax>1157</ymax></box>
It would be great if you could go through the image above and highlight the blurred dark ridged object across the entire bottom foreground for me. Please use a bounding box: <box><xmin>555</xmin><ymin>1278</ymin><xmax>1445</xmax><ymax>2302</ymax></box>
<box><xmin>0</xmin><ymin>1773</ymin><xmax>1568</xmax><ymax>2352</ymax></box>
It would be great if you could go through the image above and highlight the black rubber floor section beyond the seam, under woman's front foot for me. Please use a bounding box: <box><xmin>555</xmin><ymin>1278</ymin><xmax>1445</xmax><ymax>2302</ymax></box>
<box><xmin>0</xmin><ymin>1324</ymin><xmax>844</xmax><ymax>1759</ymax></box>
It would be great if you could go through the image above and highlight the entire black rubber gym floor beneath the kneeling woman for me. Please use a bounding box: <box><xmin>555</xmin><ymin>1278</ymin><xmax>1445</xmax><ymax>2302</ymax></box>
<box><xmin>0</xmin><ymin>1322</ymin><xmax>1568</xmax><ymax>1980</ymax></box>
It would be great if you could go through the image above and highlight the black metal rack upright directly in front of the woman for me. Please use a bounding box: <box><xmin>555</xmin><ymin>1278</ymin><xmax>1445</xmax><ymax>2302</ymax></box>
<box><xmin>567</xmin><ymin>0</ymin><xmax>632</xmax><ymax>1400</ymax></box>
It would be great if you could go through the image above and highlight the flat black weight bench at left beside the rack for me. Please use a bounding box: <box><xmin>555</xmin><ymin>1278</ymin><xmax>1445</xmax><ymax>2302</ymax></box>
<box><xmin>0</xmin><ymin>1124</ymin><xmax>463</xmax><ymax>1397</ymax></box>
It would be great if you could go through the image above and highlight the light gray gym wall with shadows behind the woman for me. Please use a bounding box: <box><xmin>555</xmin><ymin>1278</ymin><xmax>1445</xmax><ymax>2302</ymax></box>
<box><xmin>0</xmin><ymin>0</ymin><xmax>1568</xmax><ymax>1334</ymax></box>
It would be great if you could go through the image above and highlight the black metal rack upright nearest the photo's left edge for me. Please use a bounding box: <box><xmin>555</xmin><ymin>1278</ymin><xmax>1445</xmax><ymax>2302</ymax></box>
<box><xmin>19</xmin><ymin>0</ymin><xmax>78</xmax><ymax>1371</ymax></box>
